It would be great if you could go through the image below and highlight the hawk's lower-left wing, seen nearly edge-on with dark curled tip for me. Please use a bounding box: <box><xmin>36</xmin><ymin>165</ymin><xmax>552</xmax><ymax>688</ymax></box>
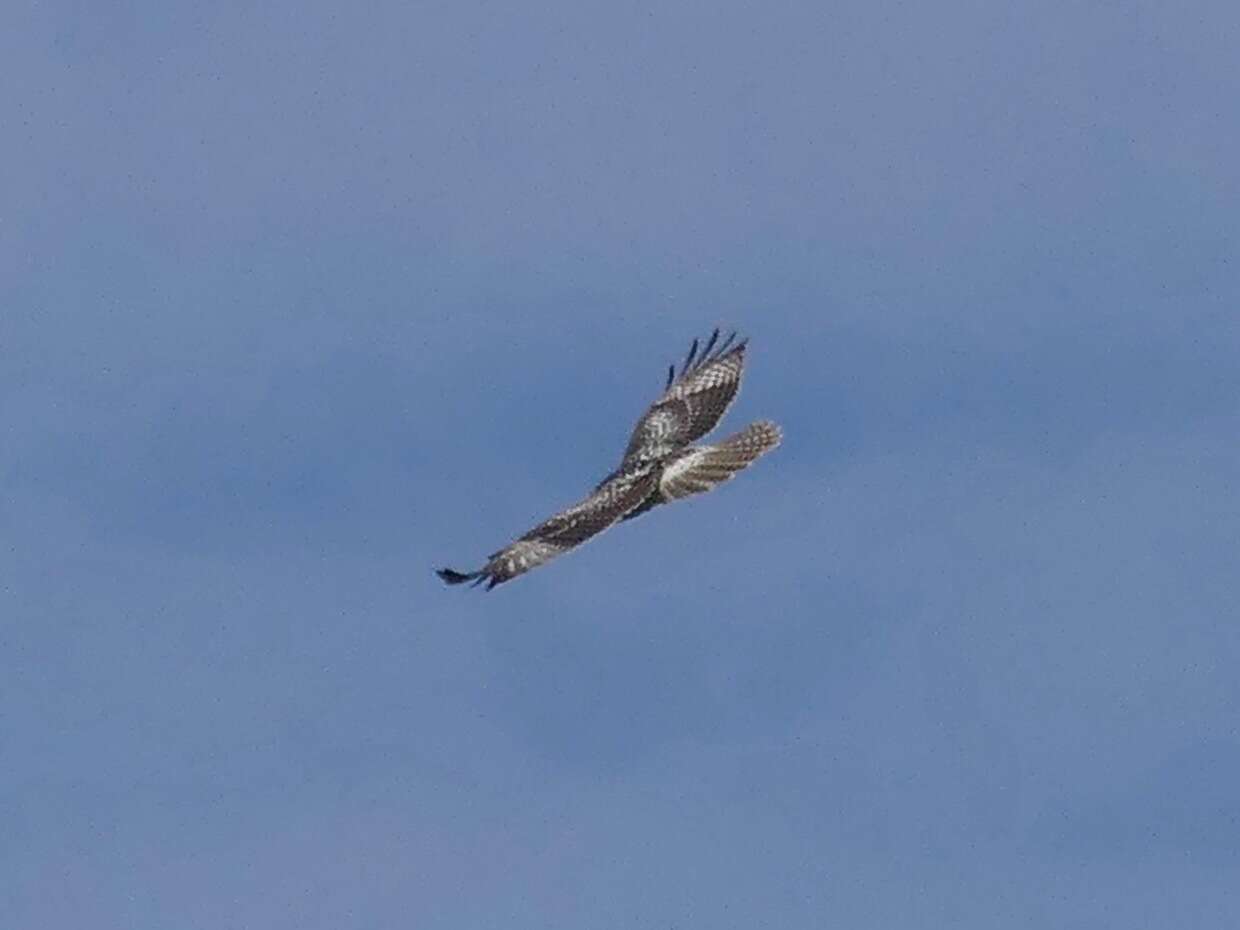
<box><xmin>438</xmin><ymin>469</ymin><xmax>656</xmax><ymax>590</ymax></box>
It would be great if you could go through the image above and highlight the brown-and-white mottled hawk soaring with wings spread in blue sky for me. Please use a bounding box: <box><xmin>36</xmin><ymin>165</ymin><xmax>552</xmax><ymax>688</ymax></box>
<box><xmin>436</xmin><ymin>330</ymin><xmax>782</xmax><ymax>590</ymax></box>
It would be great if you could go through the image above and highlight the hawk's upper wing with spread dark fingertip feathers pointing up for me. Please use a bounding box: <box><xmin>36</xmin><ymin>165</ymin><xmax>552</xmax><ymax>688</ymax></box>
<box><xmin>624</xmin><ymin>330</ymin><xmax>745</xmax><ymax>465</ymax></box>
